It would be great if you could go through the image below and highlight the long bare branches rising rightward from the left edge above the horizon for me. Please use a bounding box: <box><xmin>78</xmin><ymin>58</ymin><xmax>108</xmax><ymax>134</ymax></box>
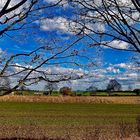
<box><xmin>0</xmin><ymin>37</ymin><xmax>94</xmax><ymax>95</ymax></box>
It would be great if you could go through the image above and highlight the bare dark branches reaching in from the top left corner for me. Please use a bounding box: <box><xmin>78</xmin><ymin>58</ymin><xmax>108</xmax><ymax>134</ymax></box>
<box><xmin>0</xmin><ymin>0</ymin><xmax>65</xmax><ymax>37</ymax></box>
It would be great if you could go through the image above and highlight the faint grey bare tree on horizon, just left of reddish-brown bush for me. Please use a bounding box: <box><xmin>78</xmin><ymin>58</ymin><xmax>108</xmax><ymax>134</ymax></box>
<box><xmin>44</xmin><ymin>82</ymin><xmax>58</xmax><ymax>95</ymax></box>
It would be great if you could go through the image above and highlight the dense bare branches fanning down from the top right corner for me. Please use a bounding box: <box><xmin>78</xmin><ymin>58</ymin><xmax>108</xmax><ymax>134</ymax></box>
<box><xmin>70</xmin><ymin>0</ymin><xmax>140</xmax><ymax>53</ymax></box>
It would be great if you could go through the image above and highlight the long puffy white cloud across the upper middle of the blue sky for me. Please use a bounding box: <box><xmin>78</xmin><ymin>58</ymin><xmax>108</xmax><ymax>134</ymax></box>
<box><xmin>36</xmin><ymin>17</ymin><xmax>105</xmax><ymax>34</ymax></box>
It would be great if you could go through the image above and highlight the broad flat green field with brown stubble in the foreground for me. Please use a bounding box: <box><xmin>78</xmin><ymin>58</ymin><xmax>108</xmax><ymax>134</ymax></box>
<box><xmin>0</xmin><ymin>96</ymin><xmax>140</xmax><ymax>140</ymax></box>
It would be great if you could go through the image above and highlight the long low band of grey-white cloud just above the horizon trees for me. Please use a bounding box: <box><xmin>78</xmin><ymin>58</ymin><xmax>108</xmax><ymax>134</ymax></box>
<box><xmin>3</xmin><ymin>63</ymin><xmax>139</xmax><ymax>90</ymax></box>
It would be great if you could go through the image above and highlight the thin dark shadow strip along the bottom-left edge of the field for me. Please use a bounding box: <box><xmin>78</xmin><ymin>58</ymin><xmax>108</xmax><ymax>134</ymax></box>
<box><xmin>0</xmin><ymin>137</ymin><xmax>65</xmax><ymax>140</ymax></box>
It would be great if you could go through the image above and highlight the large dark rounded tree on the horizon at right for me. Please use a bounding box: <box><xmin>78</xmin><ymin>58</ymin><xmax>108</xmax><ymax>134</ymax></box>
<box><xmin>107</xmin><ymin>79</ymin><xmax>121</xmax><ymax>93</ymax></box>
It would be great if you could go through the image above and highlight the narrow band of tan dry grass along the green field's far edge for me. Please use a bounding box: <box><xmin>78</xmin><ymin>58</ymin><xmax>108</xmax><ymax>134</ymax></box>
<box><xmin>0</xmin><ymin>95</ymin><xmax>140</xmax><ymax>104</ymax></box>
